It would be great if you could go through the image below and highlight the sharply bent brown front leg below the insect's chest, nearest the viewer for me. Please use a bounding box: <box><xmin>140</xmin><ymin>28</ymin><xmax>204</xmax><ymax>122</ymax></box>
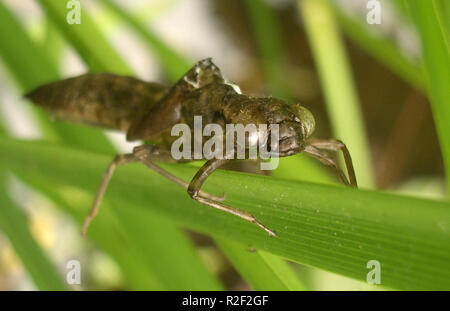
<box><xmin>188</xmin><ymin>159</ymin><xmax>276</xmax><ymax>236</ymax></box>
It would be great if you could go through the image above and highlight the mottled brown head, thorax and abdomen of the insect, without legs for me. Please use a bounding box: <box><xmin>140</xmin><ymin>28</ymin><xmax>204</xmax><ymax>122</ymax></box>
<box><xmin>27</xmin><ymin>61</ymin><xmax>314</xmax><ymax>156</ymax></box>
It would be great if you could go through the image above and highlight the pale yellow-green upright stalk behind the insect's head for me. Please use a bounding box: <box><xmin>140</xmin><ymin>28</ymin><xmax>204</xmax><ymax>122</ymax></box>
<box><xmin>297</xmin><ymin>0</ymin><xmax>374</xmax><ymax>187</ymax></box>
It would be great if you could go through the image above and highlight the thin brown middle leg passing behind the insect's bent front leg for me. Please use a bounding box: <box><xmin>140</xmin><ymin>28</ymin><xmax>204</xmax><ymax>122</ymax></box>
<box><xmin>133</xmin><ymin>145</ymin><xmax>225</xmax><ymax>201</ymax></box>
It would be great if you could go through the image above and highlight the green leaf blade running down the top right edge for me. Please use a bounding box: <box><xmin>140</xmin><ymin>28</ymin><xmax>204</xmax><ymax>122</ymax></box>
<box><xmin>407</xmin><ymin>0</ymin><xmax>450</xmax><ymax>194</ymax></box>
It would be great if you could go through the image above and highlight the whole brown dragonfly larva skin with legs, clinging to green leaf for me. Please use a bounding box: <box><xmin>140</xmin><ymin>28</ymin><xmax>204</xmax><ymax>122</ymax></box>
<box><xmin>27</xmin><ymin>59</ymin><xmax>357</xmax><ymax>236</ymax></box>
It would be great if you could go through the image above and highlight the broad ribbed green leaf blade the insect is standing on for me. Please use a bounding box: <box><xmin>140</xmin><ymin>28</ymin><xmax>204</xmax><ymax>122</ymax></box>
<box><xmin>0</xmin><ymin>138</ymin><xmax>450</xmax><ymax>290</ymax></box>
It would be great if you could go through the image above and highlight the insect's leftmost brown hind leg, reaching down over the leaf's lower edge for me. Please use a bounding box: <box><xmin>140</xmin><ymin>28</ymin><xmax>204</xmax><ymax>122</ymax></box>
<box><xmin>81</xmin><ymin>153</ymin><xmax>138</xmax><ymax>236</ymax></box>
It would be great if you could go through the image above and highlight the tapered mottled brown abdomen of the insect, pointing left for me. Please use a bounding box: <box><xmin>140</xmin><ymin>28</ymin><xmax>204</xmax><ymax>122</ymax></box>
<box><xmin>26</xmin><ymin>73</ymin><xmax>166</xmax><ymax>131</ymax></box>
